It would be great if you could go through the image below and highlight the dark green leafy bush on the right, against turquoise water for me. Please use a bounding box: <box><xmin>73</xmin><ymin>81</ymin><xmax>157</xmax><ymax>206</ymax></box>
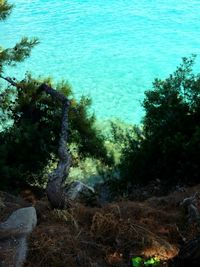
<box><xmin>120</xmin><ymin>56</ymin><xmax>200</xmax><ymax>188</ymax></box>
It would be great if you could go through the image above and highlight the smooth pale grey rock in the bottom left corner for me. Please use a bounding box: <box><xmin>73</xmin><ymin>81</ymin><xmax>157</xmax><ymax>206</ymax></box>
<box><xmin>0</xmin><ymin>207</ymin><xmax>37</xmax><ymax>267</ymax></box>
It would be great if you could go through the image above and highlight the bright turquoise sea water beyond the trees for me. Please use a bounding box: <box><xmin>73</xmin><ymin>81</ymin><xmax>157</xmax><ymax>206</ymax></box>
<box><xmin>0</xmin><ymin>0</ymin><xmax>200</xmax><ymax>122</ymax></box>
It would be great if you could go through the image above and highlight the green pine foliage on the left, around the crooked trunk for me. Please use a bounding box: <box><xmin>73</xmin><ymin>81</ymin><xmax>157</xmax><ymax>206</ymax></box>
<box><xmin>0</xmin><ymin>1</ymin><xmax>108</xmax><ymax>192</ymax></box>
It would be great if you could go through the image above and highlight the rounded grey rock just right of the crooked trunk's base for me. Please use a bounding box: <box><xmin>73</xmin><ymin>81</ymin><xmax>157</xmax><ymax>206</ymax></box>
<box><xmin>65</xmin><ymin>181</ymin><xmax>98</xmax><ymax>206</ymax></box>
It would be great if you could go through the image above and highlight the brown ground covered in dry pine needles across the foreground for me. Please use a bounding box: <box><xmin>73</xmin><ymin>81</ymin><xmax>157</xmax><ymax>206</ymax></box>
<box><xmin>0</xmin><ymin>185</ymin><xmax>200</xmax><ymax>267</ymax></box>
